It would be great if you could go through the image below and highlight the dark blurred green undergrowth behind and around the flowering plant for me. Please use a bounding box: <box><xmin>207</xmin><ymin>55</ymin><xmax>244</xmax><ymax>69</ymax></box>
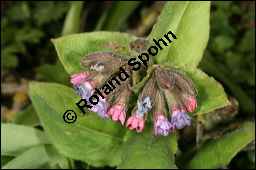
<box><xmin>1</xmin><ymin>1</ymin><xmax>255</xmax><ymax>168</ymax></box>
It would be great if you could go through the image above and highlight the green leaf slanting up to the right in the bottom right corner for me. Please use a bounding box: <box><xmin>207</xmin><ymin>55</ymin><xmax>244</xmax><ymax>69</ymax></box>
<box><xmin>187</xmin><ymin>122</ymin><xmax>255</xmax><ymax>169</ymax></box>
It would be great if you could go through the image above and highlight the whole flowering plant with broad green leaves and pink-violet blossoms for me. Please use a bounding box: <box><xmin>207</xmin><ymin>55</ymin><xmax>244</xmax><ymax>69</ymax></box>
<box><xmin>25</xmin><ymin>2</ymin><xmax>253</xmax><ymax>168</ymax></box>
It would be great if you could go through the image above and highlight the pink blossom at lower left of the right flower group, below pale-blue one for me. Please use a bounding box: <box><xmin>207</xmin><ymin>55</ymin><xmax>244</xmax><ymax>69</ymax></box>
<box><xmin>126</xmin><ymin>115</ymin><xmax>145</xmax><ymax>133</ymax></box>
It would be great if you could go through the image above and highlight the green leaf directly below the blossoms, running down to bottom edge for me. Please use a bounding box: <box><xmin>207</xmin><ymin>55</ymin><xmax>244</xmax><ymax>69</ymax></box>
<box><xmin>118</xmin><ymin>123</ymin><xmax>177</xmax><ymax>169</ymax></box>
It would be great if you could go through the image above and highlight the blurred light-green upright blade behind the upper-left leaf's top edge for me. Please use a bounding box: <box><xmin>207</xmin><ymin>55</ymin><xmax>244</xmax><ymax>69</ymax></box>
<box><xmin>62</xmin><ymin>1</ymin><xmax>84</xmax><ymax>35</ymax></box>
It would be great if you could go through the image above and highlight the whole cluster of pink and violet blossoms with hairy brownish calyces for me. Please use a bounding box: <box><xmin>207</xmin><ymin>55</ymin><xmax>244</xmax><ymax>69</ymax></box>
<box><xmin>71</xmin><ymin>39</ymin><xmax>197</xmax><ymax>136</ymax></box>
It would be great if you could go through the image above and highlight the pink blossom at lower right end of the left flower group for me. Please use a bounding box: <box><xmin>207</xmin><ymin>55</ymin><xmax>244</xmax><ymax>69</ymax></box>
<box><xmin>107</xmin><ymin>104</ymin><xmax>126</xmax><ymax>125</ymax></box>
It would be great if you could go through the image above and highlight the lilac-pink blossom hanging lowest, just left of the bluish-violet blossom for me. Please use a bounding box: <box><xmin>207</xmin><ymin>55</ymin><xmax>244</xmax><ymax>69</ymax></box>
<box><xmin>154</xmin><ymin>114</ymin><xmax>172</xmax><ymax>136</ymax></box>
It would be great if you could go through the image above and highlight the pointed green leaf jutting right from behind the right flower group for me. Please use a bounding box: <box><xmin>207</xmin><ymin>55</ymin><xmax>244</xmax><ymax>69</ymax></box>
<box><xmin>162</xmin><ymin>63</ymin><xmax>230</xmax><ymax>115</ymax></box>
